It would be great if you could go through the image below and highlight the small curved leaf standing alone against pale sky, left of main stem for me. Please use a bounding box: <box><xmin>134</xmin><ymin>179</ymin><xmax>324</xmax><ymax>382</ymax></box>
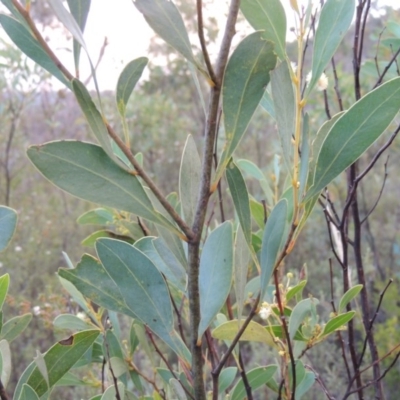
<box><xmin>116</xmin><ymin>57</ymin><xmax>149</xmax><ymax>118</ymax></box>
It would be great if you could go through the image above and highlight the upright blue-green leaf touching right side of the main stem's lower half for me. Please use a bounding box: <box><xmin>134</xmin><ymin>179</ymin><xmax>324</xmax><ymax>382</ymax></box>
<box><xmin>198</xmin><ymin>221</ymin><xmax>233</xmax><ymax>338</ymax></box>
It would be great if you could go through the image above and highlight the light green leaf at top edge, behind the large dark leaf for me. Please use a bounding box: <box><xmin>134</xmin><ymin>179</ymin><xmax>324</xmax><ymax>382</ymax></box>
<box><xmin>240</xmin><ymin>0</ymin><xmax>286</xmax><ymax>60</ymax></box>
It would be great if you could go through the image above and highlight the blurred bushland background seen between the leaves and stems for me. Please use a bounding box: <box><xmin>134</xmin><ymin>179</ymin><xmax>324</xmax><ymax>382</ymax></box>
<box><xmin>0</xmin><ymin>0</ymin><xmax>400</xmax><ymax>399</ymax></box>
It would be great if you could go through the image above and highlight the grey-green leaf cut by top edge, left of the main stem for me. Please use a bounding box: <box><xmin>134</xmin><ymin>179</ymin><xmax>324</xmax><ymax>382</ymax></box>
<box><xmin>133</xmin><ymin>0</ymin><xmax>196</xmax><ymax>64</ymax></box>
